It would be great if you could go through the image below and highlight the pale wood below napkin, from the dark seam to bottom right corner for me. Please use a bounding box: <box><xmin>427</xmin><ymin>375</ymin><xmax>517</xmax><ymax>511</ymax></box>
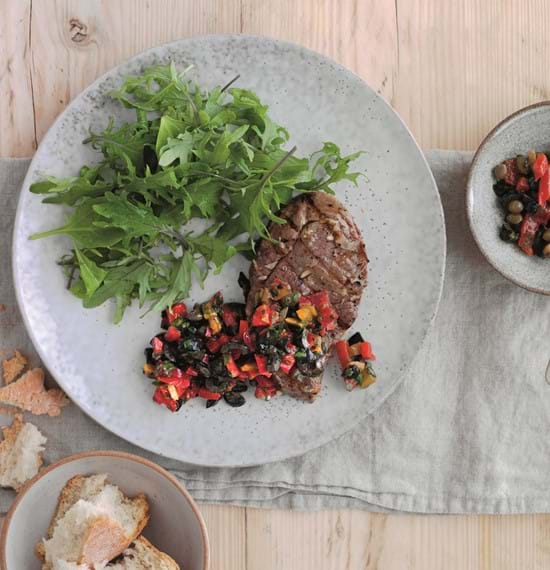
<box><xmin>247</xmin><ymin>509</ymin><xmax>550</xmax><ymax>570</ymax></box>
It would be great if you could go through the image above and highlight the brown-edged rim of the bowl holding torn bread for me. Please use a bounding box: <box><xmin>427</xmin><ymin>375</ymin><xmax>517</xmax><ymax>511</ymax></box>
<box><xmin>0</xmin><ymin>450</ymin><xmax>210</xmax><ymax>570</ymax></box>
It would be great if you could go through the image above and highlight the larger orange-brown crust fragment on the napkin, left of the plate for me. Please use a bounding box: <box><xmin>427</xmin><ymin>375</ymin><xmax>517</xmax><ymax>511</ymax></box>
<box><xmin>0</xmin><ymin>368</ymin><xmax>69</xmax><ymax>416</ymax></box>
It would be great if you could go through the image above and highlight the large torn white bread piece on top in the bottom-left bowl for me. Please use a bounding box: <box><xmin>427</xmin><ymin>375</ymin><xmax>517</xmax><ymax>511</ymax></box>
<box><xmin>36</xmin><ymin>474</ymin><xmax>149</xmax><ymax>570</ymax></box>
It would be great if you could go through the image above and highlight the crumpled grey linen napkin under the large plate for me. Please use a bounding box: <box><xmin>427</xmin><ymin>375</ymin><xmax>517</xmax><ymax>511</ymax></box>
<box><xmin>0</xmin><ymin>151</ymin><xmax>550</xmax><ymax>513</ymax></box>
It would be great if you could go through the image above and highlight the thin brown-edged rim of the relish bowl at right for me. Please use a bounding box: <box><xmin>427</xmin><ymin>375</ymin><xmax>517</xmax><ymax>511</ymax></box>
<box><xmin>464</xmin><ymin>100</ymin><xmax>550</xmax><ymax>295</ymax></box>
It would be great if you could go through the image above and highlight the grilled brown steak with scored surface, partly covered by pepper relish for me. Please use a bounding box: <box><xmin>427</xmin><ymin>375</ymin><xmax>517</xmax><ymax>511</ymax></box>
<box><xmin>247</xmin><ymin>192</ymin><xmax>368</xmax><ymax>401</ymax></box>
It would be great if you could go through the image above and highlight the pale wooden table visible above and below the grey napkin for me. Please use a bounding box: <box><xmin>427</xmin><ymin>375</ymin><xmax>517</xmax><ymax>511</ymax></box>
<box><xmin>0</xmin><ymin>0</ymin><xmax>550</xmax><ymax>570</ymax></box>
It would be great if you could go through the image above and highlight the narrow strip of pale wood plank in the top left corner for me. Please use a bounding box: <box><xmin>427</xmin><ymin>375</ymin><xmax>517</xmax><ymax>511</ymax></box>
<box><xmin>0</xmin><ymin>0</ymin><xmax>36</xmax><ymax>157</ymax></box>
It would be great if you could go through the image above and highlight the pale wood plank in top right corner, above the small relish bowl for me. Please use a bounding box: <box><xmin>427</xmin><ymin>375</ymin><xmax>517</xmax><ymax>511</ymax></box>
<box><xmin>393</xmin><ymin>0</ymin><xmax>550</xmax><ymax>149</ymax></box>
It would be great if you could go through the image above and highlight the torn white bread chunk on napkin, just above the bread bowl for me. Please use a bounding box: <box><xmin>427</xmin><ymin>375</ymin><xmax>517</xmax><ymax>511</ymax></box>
<box><xmin>0</xmin><ymin>415</ymin><xmax>46</xmax><ymax>490</ymax></box>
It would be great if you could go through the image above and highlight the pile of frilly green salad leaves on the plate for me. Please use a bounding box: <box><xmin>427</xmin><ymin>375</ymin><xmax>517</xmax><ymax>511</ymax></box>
<box><xmin>31</xmin><ymin>63</ymin><xmax>359</xmax><ymax>322</ymax></box>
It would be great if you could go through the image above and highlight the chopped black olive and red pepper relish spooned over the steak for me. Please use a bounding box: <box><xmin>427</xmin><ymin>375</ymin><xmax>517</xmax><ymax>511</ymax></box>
<box><xmin>143</xmin><ymin>282</ymin><xmax>374</xmax><ymax>412</ymax></box>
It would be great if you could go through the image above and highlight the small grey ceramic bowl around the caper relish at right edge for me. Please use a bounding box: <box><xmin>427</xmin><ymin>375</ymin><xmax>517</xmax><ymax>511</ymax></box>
<box><xmin>466</xmin><ymin>101</ymin><xmax>550</xmax><ymax>295</ymax></box>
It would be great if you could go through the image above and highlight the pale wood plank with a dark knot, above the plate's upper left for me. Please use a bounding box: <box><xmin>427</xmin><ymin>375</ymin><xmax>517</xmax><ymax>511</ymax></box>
<box><xmin>31</xmin><ymin>0</ymin><xmax>240</xmax><ymax>141</ymax></box>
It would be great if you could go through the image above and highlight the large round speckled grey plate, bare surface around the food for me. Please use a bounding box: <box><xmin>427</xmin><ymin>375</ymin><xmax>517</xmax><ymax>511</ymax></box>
<box><xmin>13</xmin><ymin>36</ymin><xmax>445</xmax><ymax>466</ymax></box>
